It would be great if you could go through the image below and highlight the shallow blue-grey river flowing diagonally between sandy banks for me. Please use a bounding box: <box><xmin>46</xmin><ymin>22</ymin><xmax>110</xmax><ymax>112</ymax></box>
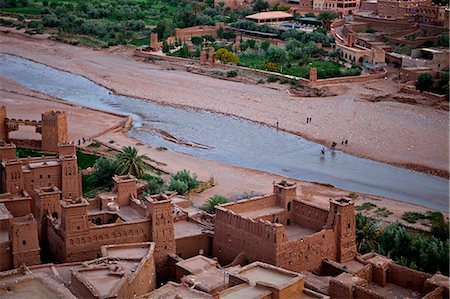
<box><xmin>0</xmin><ymin>54</ymin><xmax>449</xmax><ymax>211</ymax></box>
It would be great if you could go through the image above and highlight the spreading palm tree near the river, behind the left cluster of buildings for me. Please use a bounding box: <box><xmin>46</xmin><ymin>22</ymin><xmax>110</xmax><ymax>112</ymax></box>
<box><xmin>116</xmin><ymin>146</ymin><xmax>150</xmax><ymax>177</ymax></box>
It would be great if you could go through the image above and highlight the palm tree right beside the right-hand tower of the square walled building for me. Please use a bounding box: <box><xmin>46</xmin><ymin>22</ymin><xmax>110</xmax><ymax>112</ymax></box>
<box><xmin>356</xmin><ymin>213</ymin><xmax>380</xmax><ymax>253</ymax></box>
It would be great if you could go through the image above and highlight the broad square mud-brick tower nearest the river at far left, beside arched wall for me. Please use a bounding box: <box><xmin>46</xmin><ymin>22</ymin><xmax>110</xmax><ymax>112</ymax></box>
<box><xmin>42</xmin><ymin>111</ymin><xmax>68</xmax><ymax>153</ymax></box>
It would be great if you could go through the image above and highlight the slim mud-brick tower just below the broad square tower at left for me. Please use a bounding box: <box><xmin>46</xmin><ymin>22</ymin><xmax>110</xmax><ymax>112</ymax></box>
<box><xmin>59</xmin><ymin>155</ymin><xmax>81</xmax><ymax>198</ymax></box>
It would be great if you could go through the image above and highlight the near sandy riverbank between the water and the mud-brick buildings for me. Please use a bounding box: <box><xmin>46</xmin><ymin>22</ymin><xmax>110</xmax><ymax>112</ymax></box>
<box><xmin>0</xmin><ymin>77</ymin><xmax>446</xmax><ymax>230</ymax></box>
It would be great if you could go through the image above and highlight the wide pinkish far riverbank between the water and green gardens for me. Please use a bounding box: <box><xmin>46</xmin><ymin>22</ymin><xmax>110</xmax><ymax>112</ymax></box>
<box><xmin>0</xmin><ymin>33</ymin><xmax>449</xmax><ymax>178</ymax></box>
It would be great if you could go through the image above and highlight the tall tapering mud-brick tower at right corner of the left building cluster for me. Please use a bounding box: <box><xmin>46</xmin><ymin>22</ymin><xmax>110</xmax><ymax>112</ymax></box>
<box><xmin>147</xmin><ymin>194</ymin><xmax>176</xmax><ymax>280</ymax></box>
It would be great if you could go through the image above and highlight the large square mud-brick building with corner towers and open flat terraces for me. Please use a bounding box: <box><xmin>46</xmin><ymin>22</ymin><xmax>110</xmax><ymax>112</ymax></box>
<box><xmin>213</xmin><ymin>182</ymin><xmax>357</xmax><ymax>272</ymax></box>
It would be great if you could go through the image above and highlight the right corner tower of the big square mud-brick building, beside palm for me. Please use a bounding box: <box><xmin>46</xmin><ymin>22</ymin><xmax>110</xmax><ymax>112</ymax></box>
<box><xmin>329</xmin><ymin>198</ymin><xmax>357</xmax><ymax>263</ymax></box>
